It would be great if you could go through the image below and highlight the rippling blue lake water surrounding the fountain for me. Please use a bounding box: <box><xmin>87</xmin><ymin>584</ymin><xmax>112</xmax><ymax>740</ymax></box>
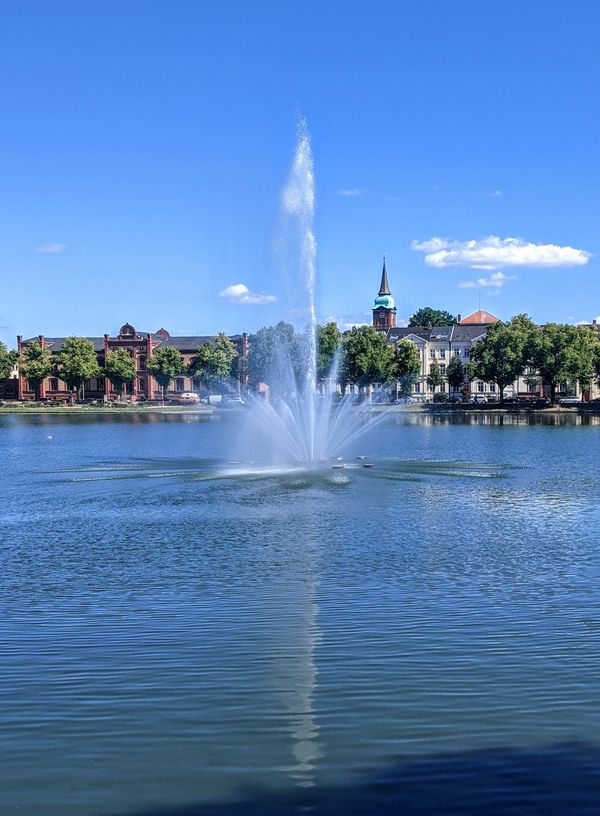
<box><xmin>0</xmin><ymin>413</ymin><xmax>600</xmax><ymax>816</ymax></box>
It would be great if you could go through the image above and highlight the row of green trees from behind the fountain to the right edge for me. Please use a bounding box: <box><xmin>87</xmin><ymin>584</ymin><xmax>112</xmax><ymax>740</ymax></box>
<box><xmin>248</xmin><ymin>310</ymin><xmax>600</xmax><ymax>402</ymax></box>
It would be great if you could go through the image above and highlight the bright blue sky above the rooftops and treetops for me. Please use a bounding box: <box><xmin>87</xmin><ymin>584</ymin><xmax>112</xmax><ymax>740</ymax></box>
<box><xmin>0</xmin><ymin>0</ymin><xmax>600</xmax><ymax>346</ymax></box>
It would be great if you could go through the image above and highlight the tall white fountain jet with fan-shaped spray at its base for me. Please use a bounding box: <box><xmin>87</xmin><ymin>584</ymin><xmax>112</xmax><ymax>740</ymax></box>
<box><xmin>243</xmin><ymin>119</ymin><xmax>382</xmax><ymax>467</ymax></box>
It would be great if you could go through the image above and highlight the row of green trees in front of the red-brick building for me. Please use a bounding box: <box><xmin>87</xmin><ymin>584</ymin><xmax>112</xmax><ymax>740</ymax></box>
<box><xmin>0</xmin><ymin>333</ymin><xmax>237</xmax><ymax>399</ymax></box>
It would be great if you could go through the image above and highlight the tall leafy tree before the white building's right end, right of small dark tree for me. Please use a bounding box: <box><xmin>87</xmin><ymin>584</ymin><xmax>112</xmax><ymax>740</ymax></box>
<box><xmin>468</xmin><ymin>315</ymin><xmax>536</xmax><ymax>405</ymax></box>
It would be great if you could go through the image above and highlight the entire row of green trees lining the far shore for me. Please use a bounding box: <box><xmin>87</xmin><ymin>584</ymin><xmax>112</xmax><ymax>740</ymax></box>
<box><xmin>0</xmin><ymin>315</ymin><xmax>600</xmax><ymax>402</ymax></box>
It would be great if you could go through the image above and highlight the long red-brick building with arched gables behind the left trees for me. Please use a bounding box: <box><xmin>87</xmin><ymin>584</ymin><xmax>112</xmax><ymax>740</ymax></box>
<box><xmin>13</xmin><ymin>323</ymin><xmax>248</xmax><ymax>402</ymax></box>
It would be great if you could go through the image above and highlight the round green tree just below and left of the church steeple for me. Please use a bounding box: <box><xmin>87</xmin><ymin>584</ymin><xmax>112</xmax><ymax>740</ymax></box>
<box><xmin>338</xmin><ymin>326</ymin><xmax>395</xmax><ymax>391</ymax></box>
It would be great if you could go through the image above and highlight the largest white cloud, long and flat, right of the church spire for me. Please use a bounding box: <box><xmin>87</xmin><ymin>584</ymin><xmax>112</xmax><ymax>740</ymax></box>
<box><xmin>411</xmin><ymin>235</ymin><xmax>591</xmax><ymax>269</ymax></box>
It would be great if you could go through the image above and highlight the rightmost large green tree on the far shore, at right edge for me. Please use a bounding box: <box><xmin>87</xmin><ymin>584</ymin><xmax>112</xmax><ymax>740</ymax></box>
<box><xmin>532</xmin><ymin>323</ymin><xmax>599</xmax><ymax>402</ymax></box>
